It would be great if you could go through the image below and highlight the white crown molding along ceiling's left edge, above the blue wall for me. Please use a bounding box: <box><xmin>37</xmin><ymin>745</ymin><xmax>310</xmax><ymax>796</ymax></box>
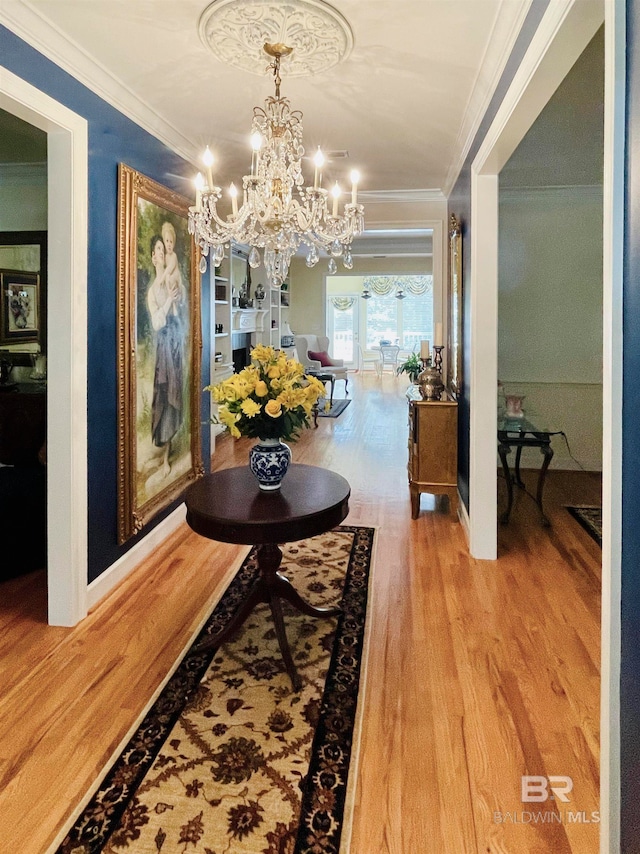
<box><xmin>0</xmin><ymin>0</ymin><xmax>198</xmax><ymax>163</ymax></box>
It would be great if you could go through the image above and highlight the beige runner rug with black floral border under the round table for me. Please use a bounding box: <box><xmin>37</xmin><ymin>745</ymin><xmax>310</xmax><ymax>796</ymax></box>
<box><xmin>58</xmin><ymin>526</ymin><xmax>374</xmax><ymax>854</ymax></box>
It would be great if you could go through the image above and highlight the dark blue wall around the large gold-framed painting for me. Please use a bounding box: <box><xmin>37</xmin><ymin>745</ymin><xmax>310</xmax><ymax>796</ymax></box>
<box><xmin>0</xmin><ymin>27</ymin><xmax>214</xmax><ymax>581</ymax></box>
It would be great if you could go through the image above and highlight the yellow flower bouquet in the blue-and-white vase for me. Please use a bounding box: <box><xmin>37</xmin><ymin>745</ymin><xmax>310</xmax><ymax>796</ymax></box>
<box><xmin>205</xmin><ymin>345</ymin><xmax>324</xmax><ymax>441</ymax></box>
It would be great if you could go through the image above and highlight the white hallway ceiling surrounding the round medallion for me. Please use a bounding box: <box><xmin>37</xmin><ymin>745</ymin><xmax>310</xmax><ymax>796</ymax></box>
<box><xmin>0</xmin><ymin>0</ymin><xmax>530</xmax><ymax>214</ymax></box>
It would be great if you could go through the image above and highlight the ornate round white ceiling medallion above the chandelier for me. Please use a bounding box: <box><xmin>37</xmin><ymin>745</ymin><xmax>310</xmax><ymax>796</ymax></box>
<box><xmin>198</xmin><ymin>0</ymin><xmax>353</xmax><ymax>77</ymax></box>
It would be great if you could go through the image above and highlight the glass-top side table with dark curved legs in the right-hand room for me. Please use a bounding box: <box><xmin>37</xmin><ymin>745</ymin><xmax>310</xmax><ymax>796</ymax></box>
<box><xmin>498</xmin><ymin>414</ymin><xmax>555</xmax><ymax>526</ymax></box>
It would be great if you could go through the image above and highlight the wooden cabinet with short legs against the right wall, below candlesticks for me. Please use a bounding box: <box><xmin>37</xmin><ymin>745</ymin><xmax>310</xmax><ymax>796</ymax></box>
<box><xmin>407</xmin><ymin>385</ymin><xmax>458</xmax><ymax>519</ymax></box>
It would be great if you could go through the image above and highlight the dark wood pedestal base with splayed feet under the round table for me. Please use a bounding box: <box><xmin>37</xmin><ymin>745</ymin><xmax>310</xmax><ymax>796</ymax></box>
<box><xmin>198</xmin><ymin>543</ymin><xmax>341</xmax><ymax>691</ymax></box>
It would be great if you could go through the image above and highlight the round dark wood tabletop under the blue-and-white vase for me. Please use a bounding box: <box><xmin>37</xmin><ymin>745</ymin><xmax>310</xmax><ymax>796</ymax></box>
<box><xmin>185</xmin><ymin>463</ymin><xmax>351</xmax><ymax>545</ymax></box>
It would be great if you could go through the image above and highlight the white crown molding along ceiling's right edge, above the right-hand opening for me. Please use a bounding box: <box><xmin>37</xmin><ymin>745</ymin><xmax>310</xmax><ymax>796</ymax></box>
<box><xmin>443</xmin><ymin>0</ymin><xmax>533</xmax><ymax>198</ymax></box>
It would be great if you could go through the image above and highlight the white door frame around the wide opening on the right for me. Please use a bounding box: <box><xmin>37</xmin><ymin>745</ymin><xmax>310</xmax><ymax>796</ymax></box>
<box><xmin>469</xmin><ymin>0</ymin><xmax>625</xmax><ymax>854</ymax></box>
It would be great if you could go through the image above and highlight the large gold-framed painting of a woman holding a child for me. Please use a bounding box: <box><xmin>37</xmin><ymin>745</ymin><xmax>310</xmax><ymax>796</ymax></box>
<box><xmin>118</xmin><ymin>163</ymin><xmax>203</xmax><ymax>543</ymax></box>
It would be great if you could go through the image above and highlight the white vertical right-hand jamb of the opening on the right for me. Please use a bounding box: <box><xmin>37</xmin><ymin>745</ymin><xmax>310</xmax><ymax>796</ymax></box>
<box><xmin>600</xmin><ymin>3</ymin><xmax>626</xmax><ymax>854</ymax></box>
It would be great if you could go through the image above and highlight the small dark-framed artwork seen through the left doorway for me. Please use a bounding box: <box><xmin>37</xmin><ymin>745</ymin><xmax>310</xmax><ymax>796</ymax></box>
<box><xmin>0</xmin><ymin>269</ymin><xmax>41</xmax><ymax>345</ymax></box>
